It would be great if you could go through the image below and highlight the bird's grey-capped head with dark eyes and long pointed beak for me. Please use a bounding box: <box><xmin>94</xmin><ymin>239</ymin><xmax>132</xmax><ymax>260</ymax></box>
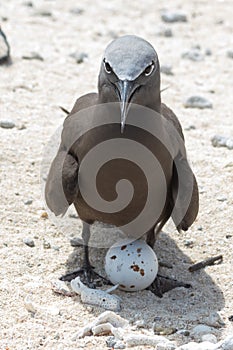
<box><xmin>98</xmin><ymin>35</ymin><xmax>161</xmax><ymax>132</ymax></box>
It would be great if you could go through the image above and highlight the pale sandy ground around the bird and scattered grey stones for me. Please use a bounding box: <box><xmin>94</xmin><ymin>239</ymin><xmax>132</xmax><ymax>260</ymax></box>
<box><xmin>0</xmin><ymin>0</ymin><xmax>233</xmax><ymax>350</ymax></box>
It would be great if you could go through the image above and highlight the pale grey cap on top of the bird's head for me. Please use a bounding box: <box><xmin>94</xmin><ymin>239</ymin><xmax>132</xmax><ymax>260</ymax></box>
<box><xmin>104</xmin><ymin>35</ymin><xmax>158</xmax><ymax>81</ymax></box>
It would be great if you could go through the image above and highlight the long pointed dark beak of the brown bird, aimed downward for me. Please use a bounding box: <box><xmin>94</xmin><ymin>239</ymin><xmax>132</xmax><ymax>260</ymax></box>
<box><xmin>116</xmin><ymin>80</ymin><xmax>138</xmax><ymax>133</ymax></box>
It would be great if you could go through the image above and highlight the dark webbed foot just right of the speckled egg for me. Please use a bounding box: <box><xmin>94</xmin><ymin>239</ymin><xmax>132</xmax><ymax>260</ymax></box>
<box><xmin>147</xmin><ymin>275</ymin><xmax>192</xmax><ymax>298</ymax></box>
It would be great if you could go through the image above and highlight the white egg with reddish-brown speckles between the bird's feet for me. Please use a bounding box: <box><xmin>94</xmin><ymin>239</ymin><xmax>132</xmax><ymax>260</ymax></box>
<box><xmin>105</xmin><ymin>239</ymin><xmax>158</xmax><ymax>291</ymax></box>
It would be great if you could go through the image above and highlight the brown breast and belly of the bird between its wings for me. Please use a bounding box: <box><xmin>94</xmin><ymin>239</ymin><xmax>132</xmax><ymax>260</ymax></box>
<box><xmin>75</xmin><ymin>124</ymin><xmax>172</xmax><ymax>226</ymax></box>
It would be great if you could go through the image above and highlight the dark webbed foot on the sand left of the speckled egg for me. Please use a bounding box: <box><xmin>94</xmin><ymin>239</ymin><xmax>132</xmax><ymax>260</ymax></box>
<box><xmin>60</xmin><ymin>265</ymin><xmax>112</xmax><ymax>288</ymax></box>
